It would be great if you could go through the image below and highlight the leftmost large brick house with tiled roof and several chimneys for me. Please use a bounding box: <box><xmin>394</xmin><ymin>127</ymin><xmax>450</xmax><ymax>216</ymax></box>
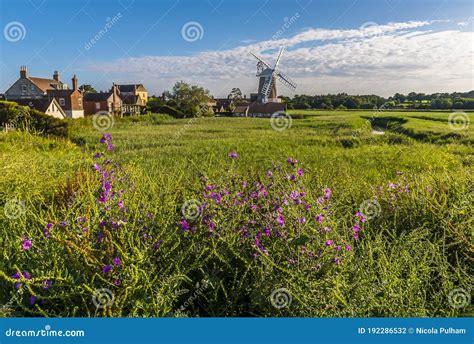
<box><xmin>5</xmin><ymin>66</ymin><xmax>84</xmax><ymax>118</ymax></box>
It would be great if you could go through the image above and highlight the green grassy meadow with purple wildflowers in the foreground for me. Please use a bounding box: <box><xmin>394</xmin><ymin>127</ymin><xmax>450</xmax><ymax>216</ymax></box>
<box><xmin>0</xmin><ymin>110</ymin><xmax>474</xmax><ymax>317</ymax></box>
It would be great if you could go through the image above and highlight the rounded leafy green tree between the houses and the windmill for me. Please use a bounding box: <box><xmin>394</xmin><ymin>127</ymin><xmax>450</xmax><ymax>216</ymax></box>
<box><xmin>171</xmin><ymin>81</ymin><xmax>213</xmax><ymax>117</ymax></box>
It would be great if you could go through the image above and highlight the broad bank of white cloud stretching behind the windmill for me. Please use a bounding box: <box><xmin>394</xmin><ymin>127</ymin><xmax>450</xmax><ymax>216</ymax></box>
<box><xmin>86</xmin><ymin>21</ymin><xmax>474</xmax><ymax>96</ymax></box>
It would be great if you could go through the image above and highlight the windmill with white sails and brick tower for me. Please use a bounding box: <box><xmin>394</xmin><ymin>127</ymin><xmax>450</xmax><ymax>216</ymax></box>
<box><xmin>250</xmin><ymin>47</ymin><xmax>296</xmax><ymax>103</ymax></box>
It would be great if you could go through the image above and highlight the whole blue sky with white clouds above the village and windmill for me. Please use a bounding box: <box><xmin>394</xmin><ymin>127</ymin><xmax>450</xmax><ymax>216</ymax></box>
<box><xmin>0</xmin><ymin>0</ymin><xmax>474</xmax><ymax>97</ymax></box>
